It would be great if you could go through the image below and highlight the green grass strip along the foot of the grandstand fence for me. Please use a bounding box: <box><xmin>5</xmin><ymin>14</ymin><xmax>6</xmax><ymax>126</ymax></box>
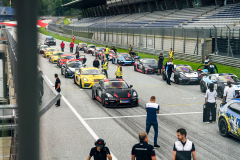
<box><xmin>38</xmin><ymin>27</ymin><xmax>240</xmax><ymax>77</ymax></box>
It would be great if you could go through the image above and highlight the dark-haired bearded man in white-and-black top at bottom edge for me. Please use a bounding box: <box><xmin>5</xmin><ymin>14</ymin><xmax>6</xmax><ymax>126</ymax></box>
<box><xmin>172</xmin><ymin>128</ymin><xmax>197</xmax><ymax>160</ymax></box>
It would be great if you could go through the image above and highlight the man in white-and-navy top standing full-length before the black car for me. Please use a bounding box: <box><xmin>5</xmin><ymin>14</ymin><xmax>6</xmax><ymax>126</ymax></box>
<box><xmin>145</xmin><ymin>96</ymin><xmax>160</xmax><ymax>148</ymax></box>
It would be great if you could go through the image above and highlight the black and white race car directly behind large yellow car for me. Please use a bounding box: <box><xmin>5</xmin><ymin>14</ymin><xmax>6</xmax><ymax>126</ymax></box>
<box><xmin>61</xmin><ymin>61</ymin><xmax>85</xmax><ymax>78</ymax></box>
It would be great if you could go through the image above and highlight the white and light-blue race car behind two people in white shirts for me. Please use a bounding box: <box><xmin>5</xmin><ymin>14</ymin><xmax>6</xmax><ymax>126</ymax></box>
<box><xmin>200</xmin><ymin>73</ymin><xmax>240</xmax><ymax>98</ymax></box>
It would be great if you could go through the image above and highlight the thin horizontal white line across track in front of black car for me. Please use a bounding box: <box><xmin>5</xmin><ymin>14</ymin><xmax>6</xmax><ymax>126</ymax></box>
<box><xmin>84</xmin><ymin>112</ymin><xmax>203</xmax><ymax>120</ymax></box>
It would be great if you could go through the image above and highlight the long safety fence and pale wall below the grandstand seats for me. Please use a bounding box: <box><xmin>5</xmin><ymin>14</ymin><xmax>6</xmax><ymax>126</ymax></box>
<box><xmin>49</xmin><ymin>24</ymin><xmax>240</xmax><ymax>67</ymax></box>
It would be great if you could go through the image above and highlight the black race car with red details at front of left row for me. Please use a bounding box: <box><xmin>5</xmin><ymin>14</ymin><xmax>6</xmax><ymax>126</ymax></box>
<box><xmin>92</xmin><ymin>79</ymin><xmax>139</xmax><ymax>107</ymax></box>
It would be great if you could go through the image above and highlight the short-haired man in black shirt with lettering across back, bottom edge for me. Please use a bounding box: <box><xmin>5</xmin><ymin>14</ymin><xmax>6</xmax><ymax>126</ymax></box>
<box><xmin>131</xmin><ymin>132</ymin><xmax>157</xmax><ymax>160</ymax></box>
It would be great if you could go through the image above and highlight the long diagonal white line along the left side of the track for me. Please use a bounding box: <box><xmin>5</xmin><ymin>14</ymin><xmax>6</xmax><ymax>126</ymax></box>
<box><xmin>45</xmin><ymin>71</ymin><xmax>117</xmax><ymax>160</ymax></box>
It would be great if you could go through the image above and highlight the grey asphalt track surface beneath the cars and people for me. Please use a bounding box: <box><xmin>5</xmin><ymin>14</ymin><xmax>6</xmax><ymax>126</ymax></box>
<box><xmin>38</xmin><ymin>34</ymin><xmax>240</xmax><ymax>160</ymax></box>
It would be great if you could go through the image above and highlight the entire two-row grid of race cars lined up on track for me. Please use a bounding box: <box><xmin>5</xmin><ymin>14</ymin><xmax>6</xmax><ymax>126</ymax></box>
<box><xmin>37</xmin><ymin>36</ymin><xmax>240</xmax><ymax>138</ymax></box>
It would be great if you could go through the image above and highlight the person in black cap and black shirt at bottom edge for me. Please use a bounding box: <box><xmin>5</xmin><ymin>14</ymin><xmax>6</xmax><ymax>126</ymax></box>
<box><xmin>87</xmin><ymin>138</ymin><xmax>112</xmax><ymax>160</ymax></box>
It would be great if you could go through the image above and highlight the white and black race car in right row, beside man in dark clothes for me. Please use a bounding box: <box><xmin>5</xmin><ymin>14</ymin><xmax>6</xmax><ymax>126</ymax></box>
<box><xmin>162</xmin><ymin>64</ymin><xmax>201</xmax><ymax>84</ymax></box>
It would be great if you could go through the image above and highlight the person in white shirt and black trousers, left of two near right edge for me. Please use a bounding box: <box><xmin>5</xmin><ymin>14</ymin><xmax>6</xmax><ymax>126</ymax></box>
<box><xmin>203</xmin><ymin>83</ymin><xmax>217</xmax><ymax>123</ymax></box>
